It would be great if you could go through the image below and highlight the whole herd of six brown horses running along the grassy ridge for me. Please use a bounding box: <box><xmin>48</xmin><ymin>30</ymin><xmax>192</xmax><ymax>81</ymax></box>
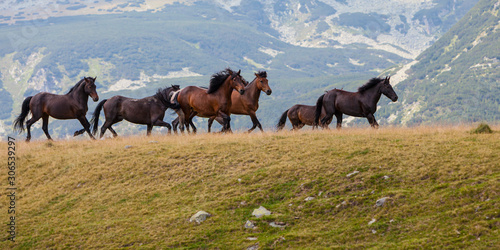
<box><xmin>13</xmin><ymin>68</ymin><xmax>398</xmax><ymax>141</ymax></box>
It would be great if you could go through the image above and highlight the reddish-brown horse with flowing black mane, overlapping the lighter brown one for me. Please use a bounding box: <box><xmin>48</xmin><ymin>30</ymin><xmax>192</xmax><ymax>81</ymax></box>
<box><xmin>177</xmin><ymin>68</ymin><xmax>245</xmax><ymax>133</ymax></box>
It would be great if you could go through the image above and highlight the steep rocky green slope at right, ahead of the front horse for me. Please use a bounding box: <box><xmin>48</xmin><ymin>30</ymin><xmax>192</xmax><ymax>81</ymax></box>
<box><xmin>381</xmin><ymin>0</ymin><xmax>500</xmax><ymax>124</ymax></box>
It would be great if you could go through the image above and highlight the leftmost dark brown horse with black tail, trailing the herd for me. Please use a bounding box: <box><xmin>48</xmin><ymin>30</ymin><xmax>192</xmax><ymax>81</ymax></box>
<box><xmin>14</xmin><ymin>77</ymin><xmax>99</xmax><ymax>141</ymax></box>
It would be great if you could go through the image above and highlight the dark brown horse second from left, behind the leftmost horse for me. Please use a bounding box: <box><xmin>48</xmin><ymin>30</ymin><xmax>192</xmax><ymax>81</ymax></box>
<box><xmin>83</xmin><ymin>85</ymin><xmax>179</xmax><ymax>138</ymax></box>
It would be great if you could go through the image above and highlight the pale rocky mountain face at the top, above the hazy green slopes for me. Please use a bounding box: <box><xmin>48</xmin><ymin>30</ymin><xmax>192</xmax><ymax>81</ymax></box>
<box><xmin>217</xmin><ymin>0</ymin><xmax>477</xmax><ymax>59</ymax></box>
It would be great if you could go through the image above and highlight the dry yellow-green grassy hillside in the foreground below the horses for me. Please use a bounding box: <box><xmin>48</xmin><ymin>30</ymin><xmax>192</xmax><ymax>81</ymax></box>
<box><xmin>0</xmin><ymin>126</ymin><xmax>500</xmax><ymax>249</ymax></box>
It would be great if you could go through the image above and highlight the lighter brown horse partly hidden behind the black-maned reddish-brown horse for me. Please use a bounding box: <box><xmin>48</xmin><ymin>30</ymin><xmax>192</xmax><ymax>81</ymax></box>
<box><xmin>172</xmin><ymin>71</ymin><xmax>272</xmax><ymax>133</ymax></box>
